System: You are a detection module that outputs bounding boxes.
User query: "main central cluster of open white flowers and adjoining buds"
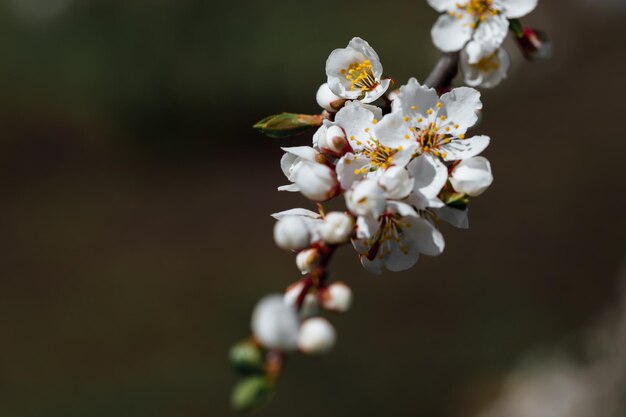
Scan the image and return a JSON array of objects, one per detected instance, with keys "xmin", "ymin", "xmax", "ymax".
[{"xmin": 274, "ymin": 38, "xmax": 493, "ymax": 273}]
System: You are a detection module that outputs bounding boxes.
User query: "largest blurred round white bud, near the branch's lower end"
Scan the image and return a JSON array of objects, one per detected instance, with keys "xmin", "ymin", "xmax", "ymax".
[{"xmin": 252, "ymin": 295, "xmax": 299, "ymax": 352}]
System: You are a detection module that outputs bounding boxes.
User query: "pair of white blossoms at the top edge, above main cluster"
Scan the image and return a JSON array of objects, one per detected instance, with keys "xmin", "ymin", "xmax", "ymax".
[{"xmin": 428, "ymin": 0, "xmax": 538, "ymax": 88}]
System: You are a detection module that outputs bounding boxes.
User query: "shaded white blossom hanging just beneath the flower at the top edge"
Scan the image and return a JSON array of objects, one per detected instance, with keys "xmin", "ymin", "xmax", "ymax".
[{"xmin": 460, "ymin": 48, "xmax": 511, "ymax": 88}]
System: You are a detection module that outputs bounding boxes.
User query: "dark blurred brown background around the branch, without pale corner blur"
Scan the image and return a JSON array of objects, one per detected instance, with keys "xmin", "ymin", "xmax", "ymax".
[{"xmin": 0, "ymin": 0, "xmax": 626, "ymax": 417}]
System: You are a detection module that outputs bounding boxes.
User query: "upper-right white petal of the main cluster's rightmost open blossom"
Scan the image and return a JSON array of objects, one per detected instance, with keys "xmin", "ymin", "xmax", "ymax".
[{"xmin": 441, "ymin": 87, "xmax": 483, "ymax": 135}]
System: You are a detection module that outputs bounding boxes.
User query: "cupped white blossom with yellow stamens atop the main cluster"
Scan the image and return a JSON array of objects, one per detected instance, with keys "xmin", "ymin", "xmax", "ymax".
[{"xmin": 326, "ymin": 38, "xmax": 391, "ymax": 103}]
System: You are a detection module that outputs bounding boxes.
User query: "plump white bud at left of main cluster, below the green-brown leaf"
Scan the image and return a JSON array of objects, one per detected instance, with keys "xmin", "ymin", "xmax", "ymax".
[{"xmin": 293, "ymin": 161, "xmax": 339, "ymax": 201}]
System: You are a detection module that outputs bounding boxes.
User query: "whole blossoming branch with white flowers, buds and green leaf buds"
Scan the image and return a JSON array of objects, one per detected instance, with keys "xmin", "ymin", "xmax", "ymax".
[{"xmin": 230, "ymin": 0, "xmax": 549, "ymax": 410}]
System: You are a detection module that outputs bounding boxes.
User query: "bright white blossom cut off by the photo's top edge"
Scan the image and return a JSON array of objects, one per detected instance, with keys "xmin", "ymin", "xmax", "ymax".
[{"xmin": 428, "ymin": 0, "xmax": 537, "ymax": 64}]
